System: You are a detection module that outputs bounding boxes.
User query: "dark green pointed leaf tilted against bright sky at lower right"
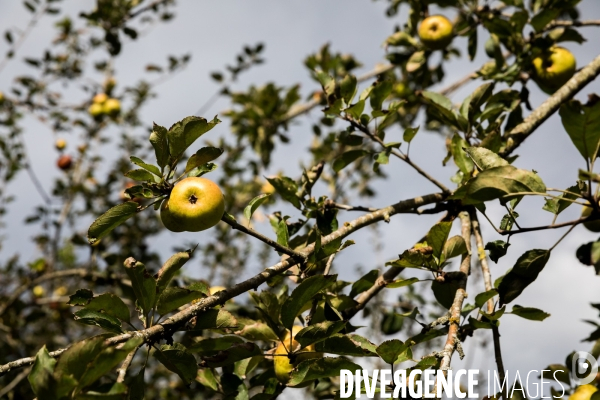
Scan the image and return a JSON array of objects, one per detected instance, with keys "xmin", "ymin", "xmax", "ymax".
[{"xmin": 498, "ymin": 249, "xmax": 550, "ymax": 305}]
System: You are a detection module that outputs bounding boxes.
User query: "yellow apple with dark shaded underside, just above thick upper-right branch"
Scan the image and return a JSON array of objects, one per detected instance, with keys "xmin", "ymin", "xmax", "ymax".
[{"xmin": 533, "ymin": 46, "xmax": 577, "ymax": 94}]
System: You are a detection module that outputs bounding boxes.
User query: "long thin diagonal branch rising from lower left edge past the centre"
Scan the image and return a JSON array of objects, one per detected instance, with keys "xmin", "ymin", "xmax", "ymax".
[{"xmin": 0, "ymin": 193, "xmax": 446, "ymax": 376}]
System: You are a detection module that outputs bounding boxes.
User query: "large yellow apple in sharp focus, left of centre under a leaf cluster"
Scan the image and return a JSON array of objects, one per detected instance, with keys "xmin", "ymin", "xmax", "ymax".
[{"xmin": 160, "ymin": 177, "xmax": 225, "ymax": 232}]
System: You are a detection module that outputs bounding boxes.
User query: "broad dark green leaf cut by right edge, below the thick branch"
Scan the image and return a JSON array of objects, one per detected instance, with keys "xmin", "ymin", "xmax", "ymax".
[{"xmin": 559, "ymin": 100, "xmax": 600, "ymax": 160}]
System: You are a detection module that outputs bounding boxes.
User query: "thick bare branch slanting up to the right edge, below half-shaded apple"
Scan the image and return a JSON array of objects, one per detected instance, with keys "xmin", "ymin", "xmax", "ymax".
[{"xmin": 499, "ymin": 52, "xmax": 600, "ymax": 157}]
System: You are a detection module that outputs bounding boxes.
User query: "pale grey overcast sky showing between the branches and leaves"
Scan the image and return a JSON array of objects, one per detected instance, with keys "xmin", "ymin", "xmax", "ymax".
[{"xmin": 0, "ymin": 0, "xmax": 600, "ymax": 394}]
